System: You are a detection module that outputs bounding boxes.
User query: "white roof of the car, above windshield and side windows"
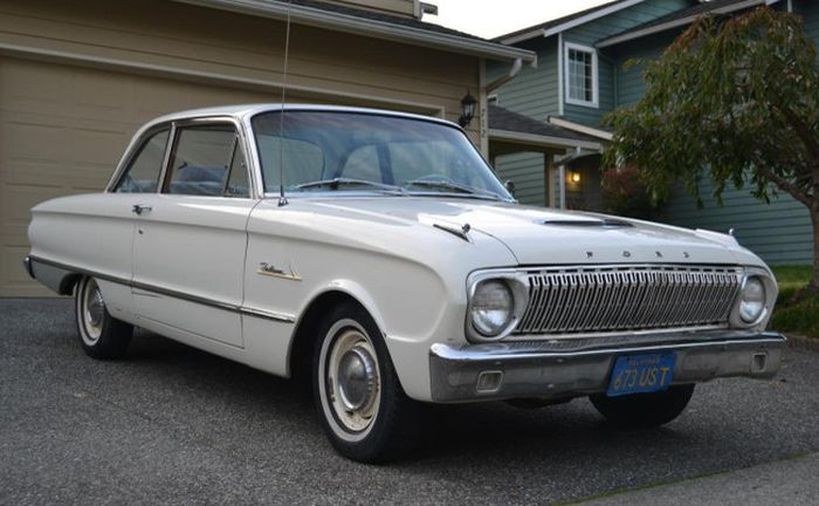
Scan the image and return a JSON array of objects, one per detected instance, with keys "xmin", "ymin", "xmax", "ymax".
[{"xmin": 143, "ymin": 103, "xmax": 460, "ymax": 130}]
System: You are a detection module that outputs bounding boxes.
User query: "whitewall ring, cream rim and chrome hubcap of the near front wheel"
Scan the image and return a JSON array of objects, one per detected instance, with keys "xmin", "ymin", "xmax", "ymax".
[{"xmin": 322, "ymin": 321, "xmax": 381, "ymax": 437}]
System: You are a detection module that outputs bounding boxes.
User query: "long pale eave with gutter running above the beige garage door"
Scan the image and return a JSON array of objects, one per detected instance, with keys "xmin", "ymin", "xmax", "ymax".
[{"xmin": 172, "ymin": 0, "xmax": 537, "ymax": 65}]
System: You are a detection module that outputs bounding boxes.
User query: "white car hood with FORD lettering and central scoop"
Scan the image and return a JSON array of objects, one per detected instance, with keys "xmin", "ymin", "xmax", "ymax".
[{"xmin": 304, "ymin": 197, "xmax": 761, "ymax": 265}]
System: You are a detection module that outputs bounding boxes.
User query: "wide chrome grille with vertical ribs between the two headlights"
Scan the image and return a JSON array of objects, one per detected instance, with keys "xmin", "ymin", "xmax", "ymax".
[{"xmin": 514, "ymin": 265, "xmax": 742, "ymax": 335}]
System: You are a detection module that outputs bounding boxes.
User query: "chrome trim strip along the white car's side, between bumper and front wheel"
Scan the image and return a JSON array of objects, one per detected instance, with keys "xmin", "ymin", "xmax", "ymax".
[{"xmin": 28, "ymin": 256, "xmax": 296, "ymax": 323}]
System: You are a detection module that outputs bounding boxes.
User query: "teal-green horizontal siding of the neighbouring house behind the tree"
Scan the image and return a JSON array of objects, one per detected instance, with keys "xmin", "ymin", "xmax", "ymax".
[{"xmin": 488, "ymin": 0, "xmax": 819, "ymax": 265}]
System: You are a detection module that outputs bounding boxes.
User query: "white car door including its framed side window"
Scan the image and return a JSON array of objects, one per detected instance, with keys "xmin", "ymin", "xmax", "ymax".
[{"xmin": 133, "ymin": 119, "xmax": 257, "ymax": 348}]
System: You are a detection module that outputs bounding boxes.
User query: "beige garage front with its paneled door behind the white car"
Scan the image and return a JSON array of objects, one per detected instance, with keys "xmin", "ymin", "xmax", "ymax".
[{"xmin": 0, "ymin": 0, "xmax": 485, "ymax": 297}]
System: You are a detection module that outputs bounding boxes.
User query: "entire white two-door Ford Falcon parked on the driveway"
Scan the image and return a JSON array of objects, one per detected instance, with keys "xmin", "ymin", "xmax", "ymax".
[{"xmin": 25, "ymin": 105, "xmax": 785, "ymax": 462}]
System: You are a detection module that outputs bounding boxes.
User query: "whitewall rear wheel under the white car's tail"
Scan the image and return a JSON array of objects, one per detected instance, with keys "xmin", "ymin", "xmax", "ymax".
[{"xmin": 74, "ymin": 277, "xmax": 134, "ymax": 359}]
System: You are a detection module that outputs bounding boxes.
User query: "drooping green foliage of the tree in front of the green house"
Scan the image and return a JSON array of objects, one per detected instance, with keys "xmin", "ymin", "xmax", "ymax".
[{"xmin": 605, "ymin": 7, "xmax": 819, "ymax": 288}]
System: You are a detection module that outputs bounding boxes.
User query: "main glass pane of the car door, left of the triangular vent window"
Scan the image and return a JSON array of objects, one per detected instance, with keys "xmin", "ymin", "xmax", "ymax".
[{"xmin": 167, "ymin": 125, "xmax": 236, "ymax": 196}]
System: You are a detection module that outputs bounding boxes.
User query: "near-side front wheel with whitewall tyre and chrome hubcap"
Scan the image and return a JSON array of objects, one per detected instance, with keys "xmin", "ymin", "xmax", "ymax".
[{"xmin": 313, "ymin": 303, "xmax": 419, "ymax": 463}]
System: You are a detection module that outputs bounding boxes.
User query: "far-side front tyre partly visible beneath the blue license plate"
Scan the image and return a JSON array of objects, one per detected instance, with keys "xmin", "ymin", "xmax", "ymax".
[{"xmin": 589, "ymin": 385, "xmax": 694, "ymax": 429}]
